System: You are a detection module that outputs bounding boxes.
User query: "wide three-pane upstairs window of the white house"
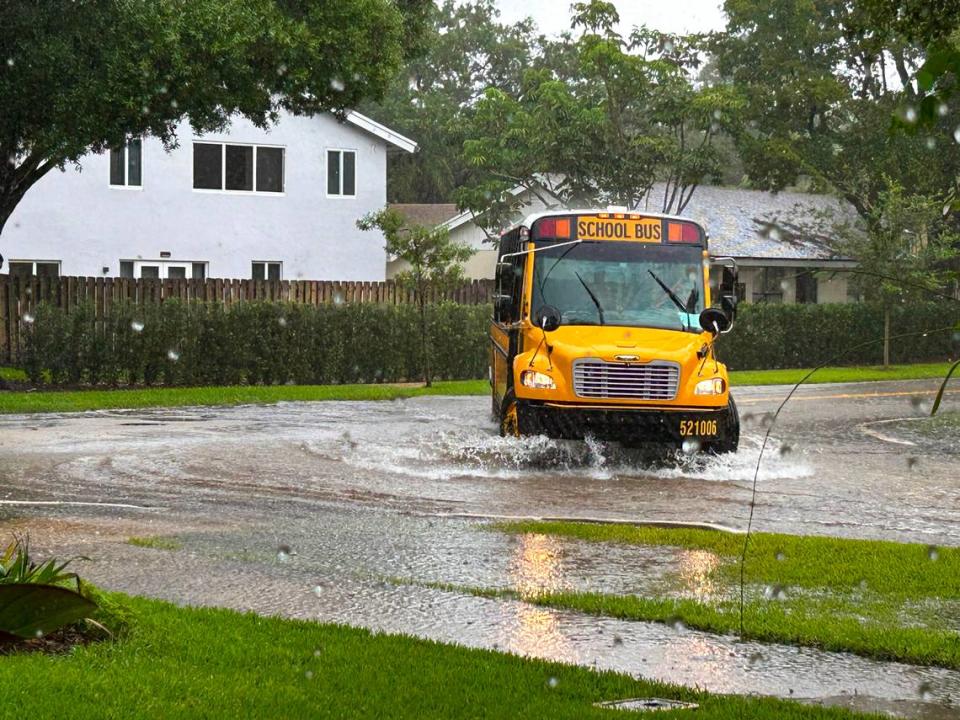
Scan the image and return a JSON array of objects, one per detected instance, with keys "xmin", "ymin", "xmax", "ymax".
[{"xmin": 193, "ymin": 142, "xmax": 284, "ymax": 193}]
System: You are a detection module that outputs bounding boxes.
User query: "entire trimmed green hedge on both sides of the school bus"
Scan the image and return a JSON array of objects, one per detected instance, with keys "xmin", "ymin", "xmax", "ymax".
[{"xmin": 15, "ymin": 301, "xmax": 960, "ymax": 385}]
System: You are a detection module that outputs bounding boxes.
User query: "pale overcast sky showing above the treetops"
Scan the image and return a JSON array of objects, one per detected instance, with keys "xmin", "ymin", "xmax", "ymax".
[{"xmin": 497, "ymin": 0, "xmax": 724, "ymax": 35}]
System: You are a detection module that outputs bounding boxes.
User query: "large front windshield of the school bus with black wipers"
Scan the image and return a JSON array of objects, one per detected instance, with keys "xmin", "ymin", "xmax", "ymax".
[{"xmin": 532, "ymin": 241, "xmax": 704, "ymax": 332}]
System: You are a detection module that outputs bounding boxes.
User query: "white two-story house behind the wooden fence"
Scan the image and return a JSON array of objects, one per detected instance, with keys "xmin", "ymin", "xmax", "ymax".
[{"xmin": 0, "ymin": 112, "xmax": 417, "ymax": 280}]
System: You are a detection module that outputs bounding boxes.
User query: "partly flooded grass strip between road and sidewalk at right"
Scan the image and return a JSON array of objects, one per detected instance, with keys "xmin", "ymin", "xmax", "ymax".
[{"xmin": 462, "ymin": 522, "xmax": 960, "ymax": 668}]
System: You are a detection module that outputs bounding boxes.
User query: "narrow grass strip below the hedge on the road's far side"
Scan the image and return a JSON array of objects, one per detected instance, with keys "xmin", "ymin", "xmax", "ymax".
[{"xmin": 0, "ymin": 363, "xmax": 949, "ymax": 413}]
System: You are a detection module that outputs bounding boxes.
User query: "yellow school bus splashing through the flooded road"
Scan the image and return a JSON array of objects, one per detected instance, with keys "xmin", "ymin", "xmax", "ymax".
[{"xmin": 490, "ymin": 210, "xmax": 740, "ymax": 453}]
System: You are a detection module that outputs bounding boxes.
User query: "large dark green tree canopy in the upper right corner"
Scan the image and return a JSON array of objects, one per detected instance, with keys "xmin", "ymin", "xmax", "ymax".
[{"xmin": 715, "ymin": 0, "xmax": 960, "ymax": 223}]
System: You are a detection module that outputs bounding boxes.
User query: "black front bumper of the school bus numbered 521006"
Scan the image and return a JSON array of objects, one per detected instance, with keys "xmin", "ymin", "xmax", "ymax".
[{"xmin": 517, "ymin": 401, "xmax": 739, "ymax": 445}]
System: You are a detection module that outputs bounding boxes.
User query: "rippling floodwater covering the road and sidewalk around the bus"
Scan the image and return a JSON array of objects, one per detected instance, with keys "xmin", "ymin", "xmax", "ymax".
[{"xmin": 0, "ymin": 381, "xmax": 960, "ymax": 718}]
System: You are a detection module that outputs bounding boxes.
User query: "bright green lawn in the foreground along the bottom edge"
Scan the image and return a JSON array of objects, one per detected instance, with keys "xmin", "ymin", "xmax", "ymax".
[{"xmin": 0, "ymin": 596, "xmax": 872, "ymax": 720}]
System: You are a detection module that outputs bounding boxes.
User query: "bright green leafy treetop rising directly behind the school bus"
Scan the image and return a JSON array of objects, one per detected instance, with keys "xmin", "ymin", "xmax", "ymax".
[{"xmin": 457, "ymin": 0, "xmax": 740, "ymax": 239}]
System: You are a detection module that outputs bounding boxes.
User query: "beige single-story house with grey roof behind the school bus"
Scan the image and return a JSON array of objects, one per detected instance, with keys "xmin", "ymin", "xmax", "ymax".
[{"xmin": 387, "ymin": 185, "xmax": 856, "ymax": 303}]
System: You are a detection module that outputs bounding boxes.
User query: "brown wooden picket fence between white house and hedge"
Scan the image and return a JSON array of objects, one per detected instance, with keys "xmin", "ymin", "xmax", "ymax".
[{"xmin": 0, "ymin": 275, "xmax": 494, "ymax": 363}]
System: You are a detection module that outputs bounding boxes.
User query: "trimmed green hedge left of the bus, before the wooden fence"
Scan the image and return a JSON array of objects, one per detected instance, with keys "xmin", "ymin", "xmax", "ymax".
[{"xmin": 23, "ymin": 301, "xmax": 491, "ymax": 385}]
